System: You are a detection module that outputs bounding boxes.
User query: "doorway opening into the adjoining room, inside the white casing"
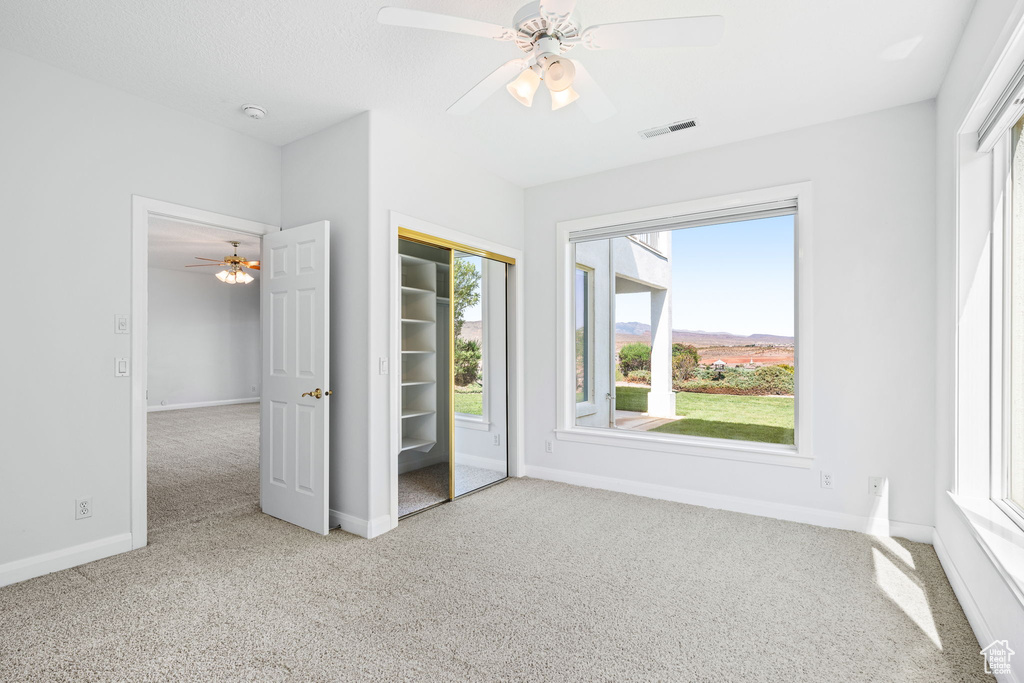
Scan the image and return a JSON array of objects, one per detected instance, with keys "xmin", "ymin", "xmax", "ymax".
[{"xmin": 146, "ymin": 216, "xmax": 262, "ymax": 531}]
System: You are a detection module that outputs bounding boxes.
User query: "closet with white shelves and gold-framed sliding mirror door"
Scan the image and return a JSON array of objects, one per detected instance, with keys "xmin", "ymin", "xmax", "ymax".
[{"xmin": 397, "ymin": 230, "xmax": 511, "ymax": 517}]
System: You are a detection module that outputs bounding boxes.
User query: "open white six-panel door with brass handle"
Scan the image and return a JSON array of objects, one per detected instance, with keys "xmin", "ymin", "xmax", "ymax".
[{"xmin": 259, "ymin": 220, "xmax": 331, "ymax": 533}]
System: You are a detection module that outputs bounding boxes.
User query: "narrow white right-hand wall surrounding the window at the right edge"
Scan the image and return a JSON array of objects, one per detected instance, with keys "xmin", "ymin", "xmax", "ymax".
[{"xmin": 935, "ymin": 0, "xmax": 1024, "ymax": 667}]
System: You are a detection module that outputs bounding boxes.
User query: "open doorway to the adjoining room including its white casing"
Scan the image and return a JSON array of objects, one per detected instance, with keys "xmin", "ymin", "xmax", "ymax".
[{"xmin": 130, "ymin": 197, "xmax": 281, "ymax": 548}]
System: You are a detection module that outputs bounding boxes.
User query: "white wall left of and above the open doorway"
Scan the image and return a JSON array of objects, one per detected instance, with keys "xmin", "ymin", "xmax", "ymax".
[{"xmin": 0, "ymin": 50, "xmax": 281, "ymax": 584}]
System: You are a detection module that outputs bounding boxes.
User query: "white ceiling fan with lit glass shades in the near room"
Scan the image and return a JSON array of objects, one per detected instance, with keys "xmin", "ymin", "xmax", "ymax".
[{"xmin": 377, "ymin": 0, "xmax": 725, "ymax": 122}]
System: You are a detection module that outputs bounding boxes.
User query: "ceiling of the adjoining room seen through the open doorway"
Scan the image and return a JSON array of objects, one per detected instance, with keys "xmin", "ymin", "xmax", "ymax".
[{"xmin": 150, "ymin": 217, "xmax": 262, "ymax": 278}]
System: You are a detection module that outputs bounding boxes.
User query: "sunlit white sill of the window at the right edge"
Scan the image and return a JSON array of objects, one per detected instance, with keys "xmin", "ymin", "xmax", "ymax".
[{"xmin": 947, "ymin": 492, "xmax": 1024, "ymax": 606}]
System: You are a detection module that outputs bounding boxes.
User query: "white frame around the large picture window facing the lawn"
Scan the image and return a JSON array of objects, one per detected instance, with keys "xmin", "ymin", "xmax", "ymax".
[{"xmin": 555, "ymin": 182, "xmax": 814, "ymax": 468}]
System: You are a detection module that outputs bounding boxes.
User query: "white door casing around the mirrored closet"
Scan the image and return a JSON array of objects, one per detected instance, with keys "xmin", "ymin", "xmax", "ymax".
[{"xmin": 388, "ymin": 211, "xmax": 526, "ymax": 528}]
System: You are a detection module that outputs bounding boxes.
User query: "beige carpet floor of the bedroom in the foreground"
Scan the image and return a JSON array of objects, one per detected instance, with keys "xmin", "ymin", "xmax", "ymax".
[{"xmin": 0, "ymin": 405, "xmax": 985, "ymax": 683}]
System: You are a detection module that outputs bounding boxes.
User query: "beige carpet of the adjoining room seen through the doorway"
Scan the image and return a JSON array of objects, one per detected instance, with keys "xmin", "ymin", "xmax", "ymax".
[{"xmin": 146, "ymin": 403, "xmax": 259, "ymax": 532}]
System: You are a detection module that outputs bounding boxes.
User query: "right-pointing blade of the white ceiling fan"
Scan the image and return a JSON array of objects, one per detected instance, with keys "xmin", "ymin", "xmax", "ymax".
[{"xmin": 581, "ymin": 15, "xmax": 725, "ymax": 50}]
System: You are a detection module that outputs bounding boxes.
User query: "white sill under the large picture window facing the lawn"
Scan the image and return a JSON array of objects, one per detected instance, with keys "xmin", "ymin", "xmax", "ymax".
[{"xmin": 555, "ymin": 427, "xmax": 814, "ymax": 469}]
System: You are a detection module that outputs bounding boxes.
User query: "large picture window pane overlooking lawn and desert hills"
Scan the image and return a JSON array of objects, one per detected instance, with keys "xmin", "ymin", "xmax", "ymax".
[{"xmin": 570, "ymin": 203, "xmax": 799, "ymax": 445}]
